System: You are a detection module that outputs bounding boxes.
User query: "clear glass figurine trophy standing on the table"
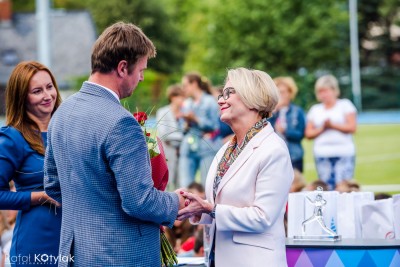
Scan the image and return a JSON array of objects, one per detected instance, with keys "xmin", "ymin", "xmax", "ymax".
[{"xmin": 293, "ymin": 186, "xmax": 341, "ymax": 241}]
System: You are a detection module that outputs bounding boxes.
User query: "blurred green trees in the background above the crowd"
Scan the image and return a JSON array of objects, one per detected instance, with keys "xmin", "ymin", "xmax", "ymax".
[{"xmin": 13, "ymin": 0, "xmax": 400, "ymax": 109}]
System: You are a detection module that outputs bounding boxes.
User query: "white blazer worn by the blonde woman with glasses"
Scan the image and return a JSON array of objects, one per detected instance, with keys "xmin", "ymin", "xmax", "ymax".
[{"xmin": 192, "ymin": 123, "xmax": 293, "ymax": 267}]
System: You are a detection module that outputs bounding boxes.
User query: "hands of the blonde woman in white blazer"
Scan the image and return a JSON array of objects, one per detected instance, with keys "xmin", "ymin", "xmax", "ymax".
[{"xmin": 177, "ymin": 191, "xmax": 214, "ymax": 220}]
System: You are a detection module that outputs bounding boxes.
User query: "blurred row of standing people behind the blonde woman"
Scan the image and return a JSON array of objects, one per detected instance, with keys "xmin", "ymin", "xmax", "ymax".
[{"xmin": 156, "ymin": 72, "xmax": 357, "ymax": 191}]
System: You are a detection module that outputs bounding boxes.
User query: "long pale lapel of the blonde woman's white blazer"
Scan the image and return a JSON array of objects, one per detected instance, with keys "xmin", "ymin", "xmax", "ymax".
[{"xmin": 214, "ymin": 123, "xmax": 274, "ymax": 198}]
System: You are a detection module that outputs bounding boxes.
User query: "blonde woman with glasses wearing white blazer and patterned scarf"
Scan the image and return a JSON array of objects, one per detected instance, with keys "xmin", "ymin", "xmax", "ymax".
[{"xmin": 178, "ymin": 68, "xmax": 293, "ymax": 267}]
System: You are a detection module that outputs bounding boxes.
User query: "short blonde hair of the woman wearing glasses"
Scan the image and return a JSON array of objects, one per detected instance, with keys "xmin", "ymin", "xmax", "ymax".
[{"xmin": 226, "ymin": 68, "xmax": 279, "ymax": 118}]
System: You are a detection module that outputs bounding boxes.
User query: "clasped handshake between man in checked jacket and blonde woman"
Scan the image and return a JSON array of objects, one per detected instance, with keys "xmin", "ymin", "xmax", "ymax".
[{"xmin": 175, "ymin": 191, "xmax": 214, "ymax": 221}]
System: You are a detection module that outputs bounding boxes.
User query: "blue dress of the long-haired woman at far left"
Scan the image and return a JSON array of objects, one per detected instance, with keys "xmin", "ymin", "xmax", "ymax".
[{"xmin": 0, "ymin": 127, "xmax": 61, "ymax": 266}]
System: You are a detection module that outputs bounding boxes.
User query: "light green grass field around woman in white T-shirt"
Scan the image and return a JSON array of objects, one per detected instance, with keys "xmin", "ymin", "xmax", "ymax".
[{"xmin": 303, "ymin": 124, "xmax": 400, "ymax": 192}]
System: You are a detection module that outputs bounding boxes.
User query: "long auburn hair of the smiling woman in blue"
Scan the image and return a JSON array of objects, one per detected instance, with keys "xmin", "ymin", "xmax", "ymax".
[{"xmin": 6, "ymin": 61, "xmax": 61, "ymax": 155}]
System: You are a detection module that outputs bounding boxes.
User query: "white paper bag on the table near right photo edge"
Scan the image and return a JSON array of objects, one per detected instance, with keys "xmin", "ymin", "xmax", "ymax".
[{"xmin": 361, "ymin": 198, "xmax": 395, "ymax": 239}]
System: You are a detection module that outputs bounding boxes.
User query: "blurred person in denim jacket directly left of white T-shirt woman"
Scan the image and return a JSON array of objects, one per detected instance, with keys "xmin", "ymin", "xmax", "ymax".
[{"xmin": 269, "ymin": 77, "xmax": 306, "ymax": 172}]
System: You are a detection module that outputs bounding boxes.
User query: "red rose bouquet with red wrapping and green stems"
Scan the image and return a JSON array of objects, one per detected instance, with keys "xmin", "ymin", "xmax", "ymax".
[{"xmin": 133, "ymin": 112, "xmax": 178, "ymax": 267}]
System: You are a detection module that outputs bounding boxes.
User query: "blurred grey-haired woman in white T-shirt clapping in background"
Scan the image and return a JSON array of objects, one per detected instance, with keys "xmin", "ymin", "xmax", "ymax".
[{"xmin": 305, "ymin": 75, "xmax": 357, "ymax": 190}]
